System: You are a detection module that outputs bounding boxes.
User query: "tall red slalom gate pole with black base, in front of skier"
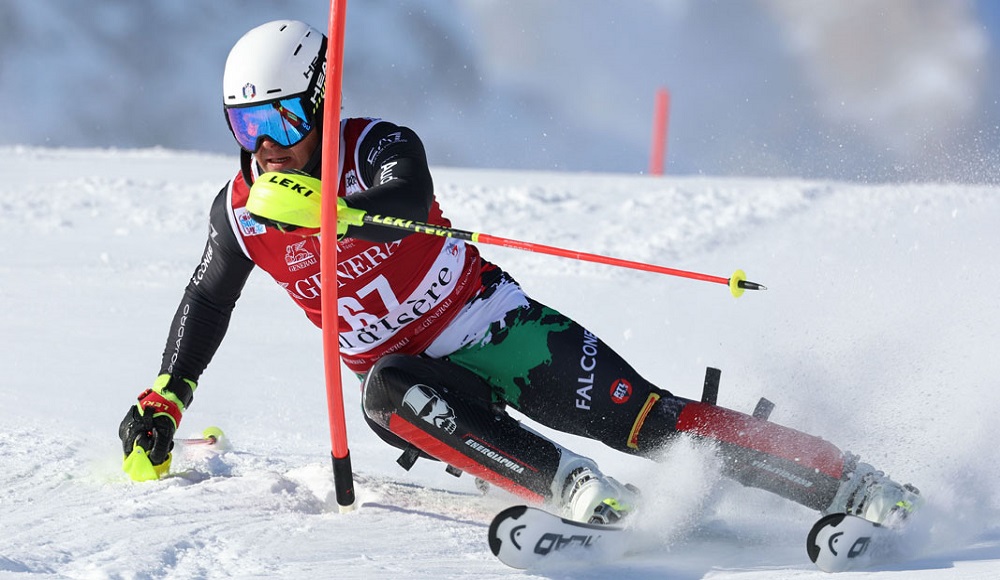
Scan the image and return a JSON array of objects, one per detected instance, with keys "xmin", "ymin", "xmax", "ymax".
[{"xmin": 320, "ymin": 0, "xmax": 355, "ymax": 512}]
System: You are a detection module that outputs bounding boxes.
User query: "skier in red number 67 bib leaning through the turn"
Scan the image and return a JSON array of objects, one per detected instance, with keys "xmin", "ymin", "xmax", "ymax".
[{"xmin": 119, "ymin": 20, "xmax": 919, "ymax": 523}]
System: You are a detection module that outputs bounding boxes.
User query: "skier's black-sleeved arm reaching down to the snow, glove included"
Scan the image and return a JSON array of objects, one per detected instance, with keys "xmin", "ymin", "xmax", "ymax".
[{"xmin": 118, "ymin": 187, "xmax": 254, "ymax": 480}]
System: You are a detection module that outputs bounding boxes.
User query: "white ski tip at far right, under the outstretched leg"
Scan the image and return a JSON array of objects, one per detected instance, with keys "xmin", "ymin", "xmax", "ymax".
[{"xmin": 806, "ymin": 514, "xmax": 899, "ymax": 572}]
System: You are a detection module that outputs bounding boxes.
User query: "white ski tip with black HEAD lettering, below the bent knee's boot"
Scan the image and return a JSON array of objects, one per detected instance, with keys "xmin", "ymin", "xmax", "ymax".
[{"xmin": 488, "ymin": 505, "xmax": 629, "ymax": 570}]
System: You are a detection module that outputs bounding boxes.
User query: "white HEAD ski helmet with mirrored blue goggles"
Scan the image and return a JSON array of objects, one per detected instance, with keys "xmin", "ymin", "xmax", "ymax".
[{"xmin": 222, "ymin": 20, "xmax": 326, "ymax": 151}]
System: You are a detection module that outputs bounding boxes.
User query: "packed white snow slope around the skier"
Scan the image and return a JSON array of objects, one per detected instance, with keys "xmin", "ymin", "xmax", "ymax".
[{"xmin": 0, "ymin": 147, "xmax": 1000, "ymax": 580}]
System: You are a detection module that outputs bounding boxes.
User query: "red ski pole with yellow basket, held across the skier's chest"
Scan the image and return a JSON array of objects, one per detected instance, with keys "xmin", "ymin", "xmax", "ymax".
[{"xmin": 358, "ymin": 209, "xmax": 767, "ymax": 298}]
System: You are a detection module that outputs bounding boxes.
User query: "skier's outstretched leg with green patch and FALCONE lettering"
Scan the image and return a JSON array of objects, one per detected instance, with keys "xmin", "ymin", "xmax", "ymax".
[{"xmin": 446, "ymin": 299, "xmax": 920, "ymax": 511}]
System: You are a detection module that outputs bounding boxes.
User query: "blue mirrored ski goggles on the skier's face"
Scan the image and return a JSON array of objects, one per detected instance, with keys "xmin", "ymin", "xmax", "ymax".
[{"xmin": 226, "ymin": 96, "xmax": 313, "ymax": 153}]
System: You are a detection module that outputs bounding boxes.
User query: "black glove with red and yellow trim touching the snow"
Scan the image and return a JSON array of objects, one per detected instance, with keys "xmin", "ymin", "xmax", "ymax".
[{"xmin": 118, "ymin": 374, "xmax": 197, "ymax": 481}]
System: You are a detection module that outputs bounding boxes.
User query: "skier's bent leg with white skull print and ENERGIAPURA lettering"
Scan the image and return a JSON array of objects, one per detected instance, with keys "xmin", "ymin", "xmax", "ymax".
[{"xmin": 362, "ymin": 355, "xmax": 632, "ymax": 521}]
